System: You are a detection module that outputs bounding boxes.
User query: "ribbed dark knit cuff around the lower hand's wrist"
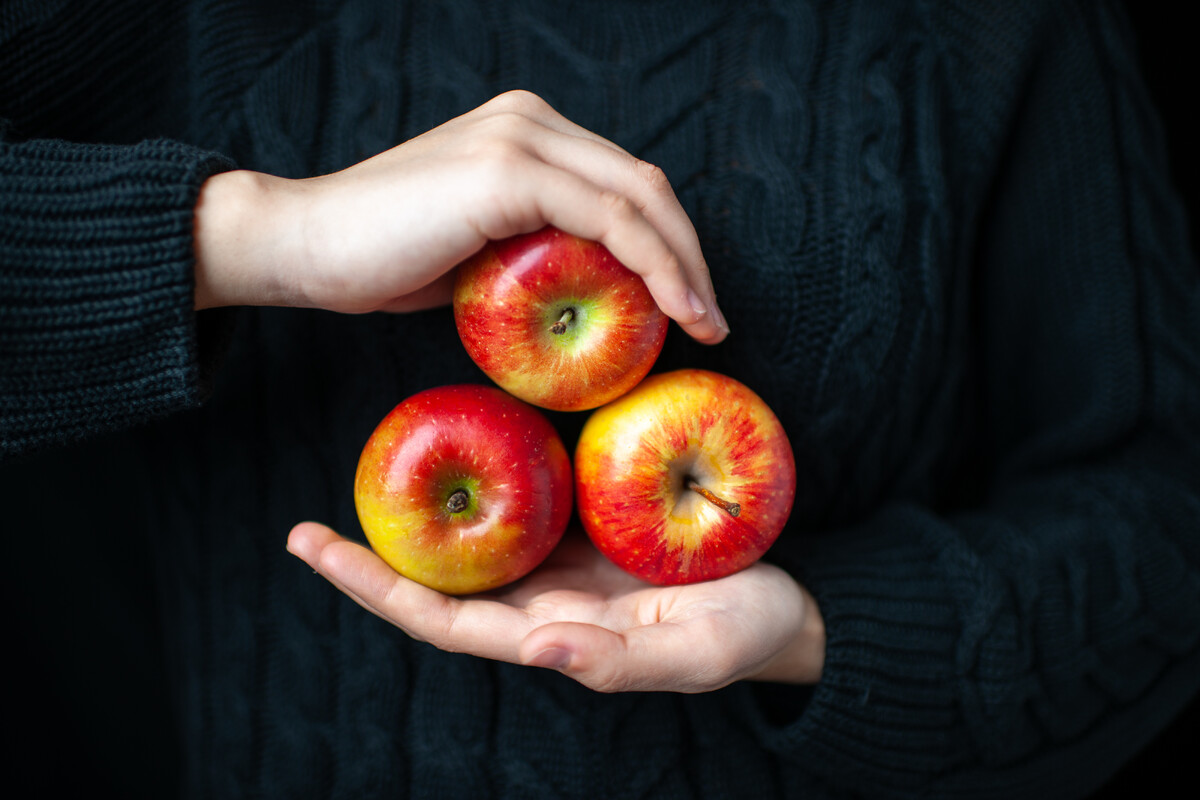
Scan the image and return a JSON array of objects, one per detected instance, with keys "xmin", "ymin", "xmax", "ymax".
[{"xmin": 750, "ymin": 507, "xmax": 967, "ymax": 796}]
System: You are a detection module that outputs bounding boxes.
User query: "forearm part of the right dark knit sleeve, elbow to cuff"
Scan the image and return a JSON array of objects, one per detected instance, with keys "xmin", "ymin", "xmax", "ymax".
[{"xmin": 749, "ymin": 479, "xmax": 1200, "ymax": 798}]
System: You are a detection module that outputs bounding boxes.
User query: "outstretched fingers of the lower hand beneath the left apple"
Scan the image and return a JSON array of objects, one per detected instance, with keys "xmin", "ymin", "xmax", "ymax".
[{"xmin": 288, "ymin": 522, "xmax": 532, "ymax": 663}]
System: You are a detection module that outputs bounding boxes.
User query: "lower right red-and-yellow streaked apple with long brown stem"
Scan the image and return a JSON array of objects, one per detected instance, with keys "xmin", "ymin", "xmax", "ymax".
[{"xmin": 575, "ymin": 369, "xmax": 796, "ymax": 585}]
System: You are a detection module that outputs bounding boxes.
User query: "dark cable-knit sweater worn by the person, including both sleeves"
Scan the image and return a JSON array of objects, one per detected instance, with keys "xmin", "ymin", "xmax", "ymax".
[{"xmin": 0, "ymin": 0, "xmax": 1200, "ymax": 799}]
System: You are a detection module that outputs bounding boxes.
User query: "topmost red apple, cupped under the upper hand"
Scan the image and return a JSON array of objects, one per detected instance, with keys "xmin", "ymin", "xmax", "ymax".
[{"xmin": 454, "ymin": 227, "xmax": 667, "ymax": 411}]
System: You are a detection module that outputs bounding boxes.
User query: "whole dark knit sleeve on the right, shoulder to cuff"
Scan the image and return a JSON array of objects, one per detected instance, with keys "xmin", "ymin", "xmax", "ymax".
[{"xmin": 754, "ymin": 4, "xmax": 1200, "ymax": 798}]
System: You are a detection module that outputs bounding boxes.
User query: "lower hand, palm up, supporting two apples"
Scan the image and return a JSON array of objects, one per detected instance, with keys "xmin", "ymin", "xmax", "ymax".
[{"xmin": 288, "ymin": 522, "xmax": 824, "ymax": 692}]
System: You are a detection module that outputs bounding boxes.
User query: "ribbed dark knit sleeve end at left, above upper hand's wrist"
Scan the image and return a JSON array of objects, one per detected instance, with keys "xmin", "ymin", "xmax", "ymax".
[{"xmin": 0, "ymin": 127, "xmax": 230, "ymax": 457}]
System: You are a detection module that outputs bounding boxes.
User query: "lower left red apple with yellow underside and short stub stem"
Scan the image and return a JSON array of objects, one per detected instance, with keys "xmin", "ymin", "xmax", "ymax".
[{"xmin": 354, "ymin": 384, "xmax": 572, "ymax": 595}]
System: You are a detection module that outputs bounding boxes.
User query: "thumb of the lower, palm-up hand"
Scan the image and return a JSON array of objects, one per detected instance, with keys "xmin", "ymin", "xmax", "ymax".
[{"xmin": 520, "ymin": 622, "xmax": 740, "ymax": 693}]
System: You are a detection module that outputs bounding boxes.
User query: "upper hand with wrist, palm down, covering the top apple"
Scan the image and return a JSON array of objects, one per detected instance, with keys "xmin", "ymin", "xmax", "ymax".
[{"xmin": 196, "ymin": 91, "xmax": 728, "ymax": 343}]
